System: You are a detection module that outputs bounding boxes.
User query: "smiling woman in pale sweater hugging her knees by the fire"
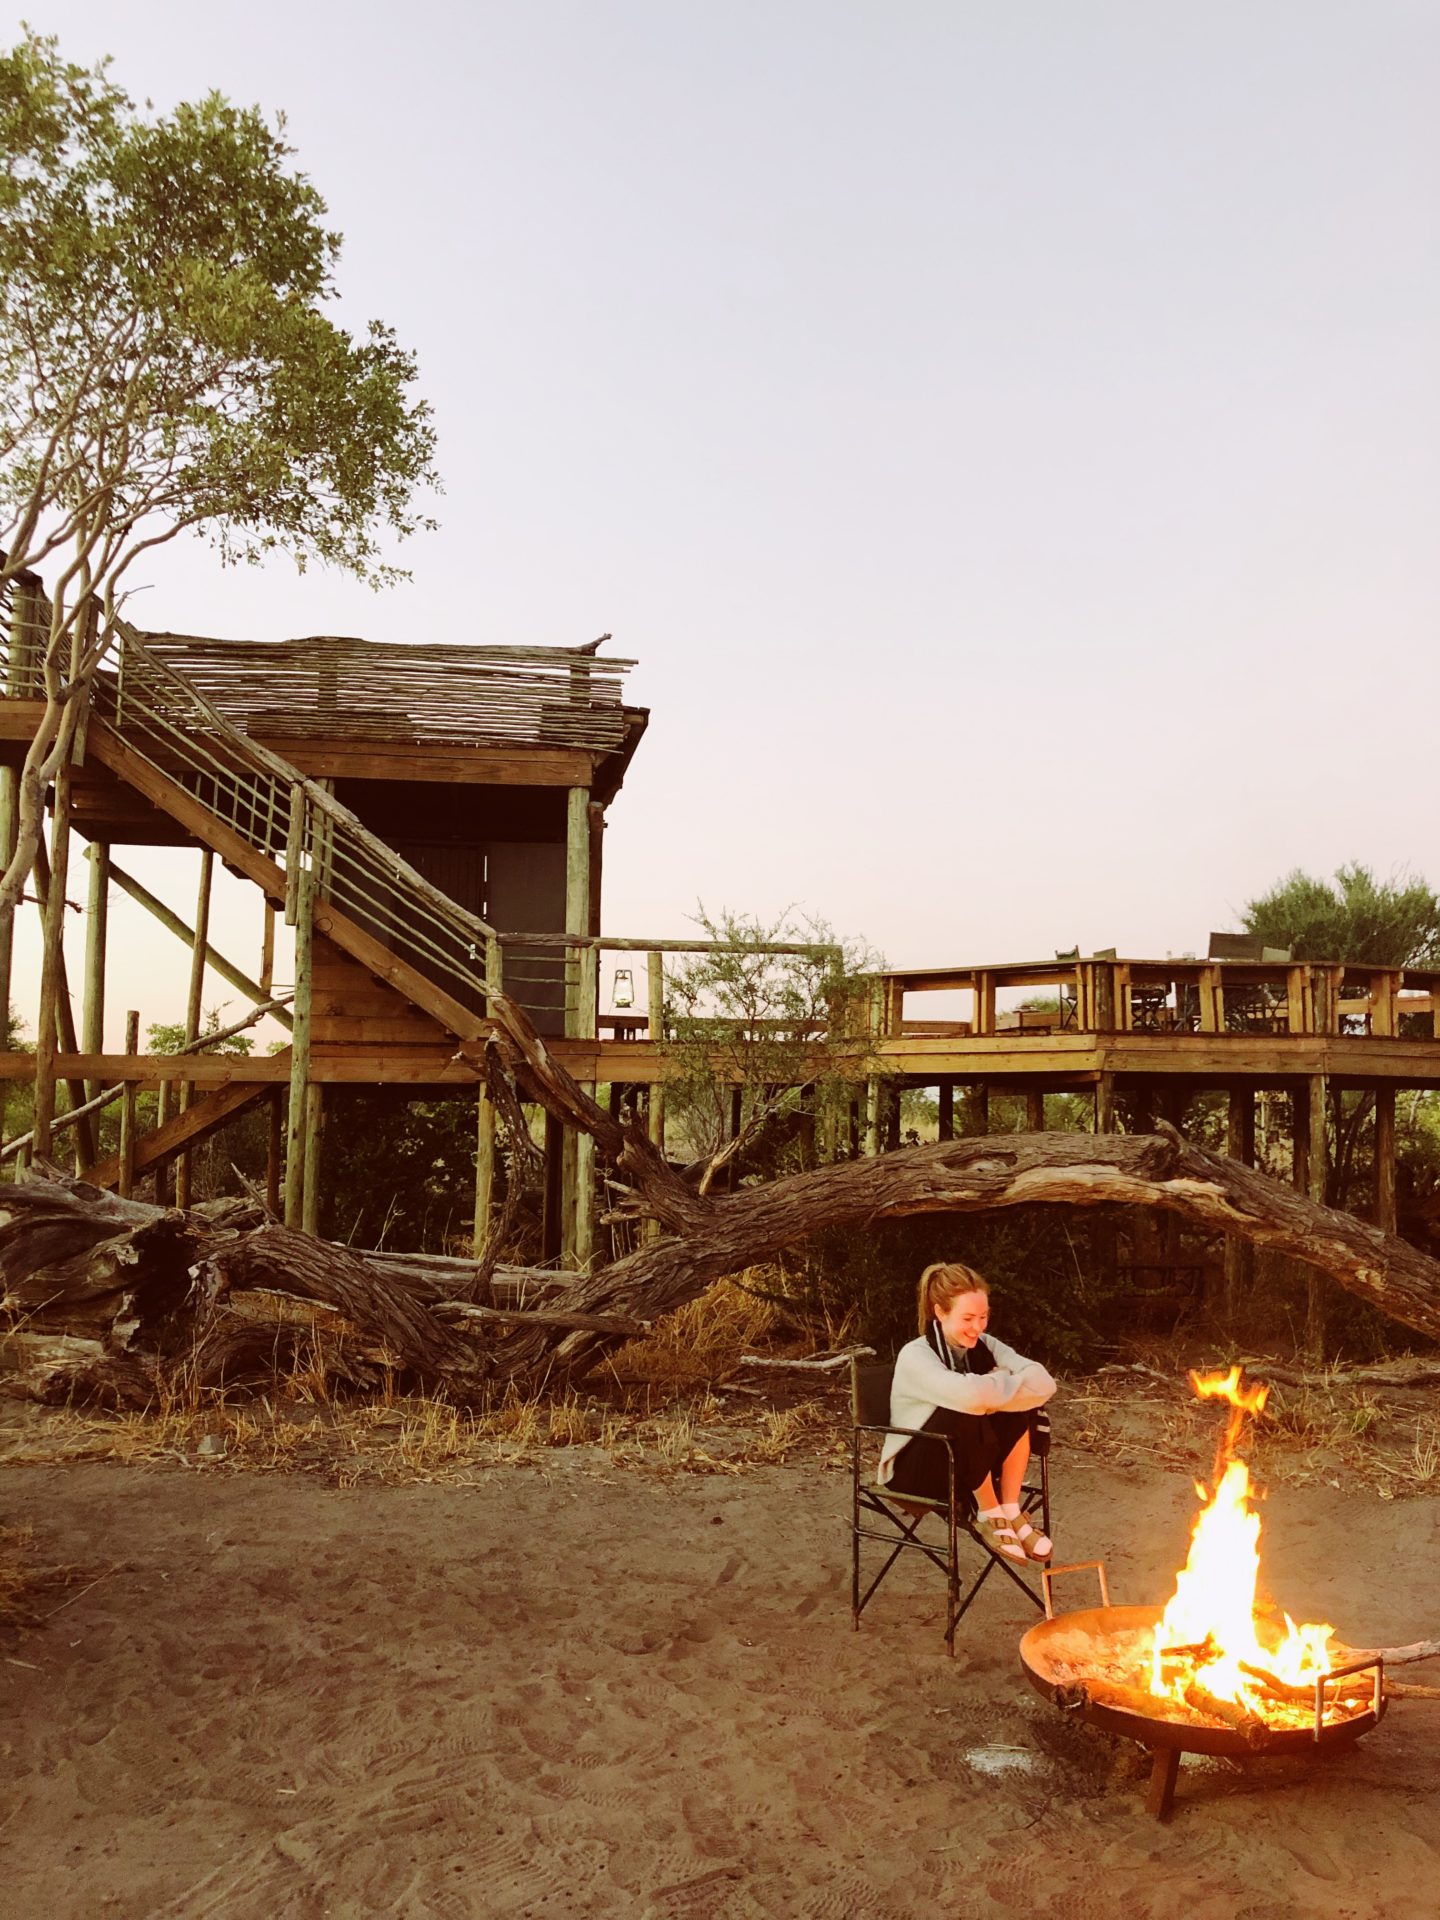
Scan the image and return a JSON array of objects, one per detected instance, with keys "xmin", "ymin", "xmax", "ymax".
[{"xmin": 879, "ymin": 1261, "xmax": 1054, "ymax": 1565}]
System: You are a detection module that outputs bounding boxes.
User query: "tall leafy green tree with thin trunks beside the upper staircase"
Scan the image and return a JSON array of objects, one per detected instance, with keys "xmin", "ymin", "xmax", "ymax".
[{"xmin": 0, "ymin": 33, "xmax": 436, "ymax": 910}]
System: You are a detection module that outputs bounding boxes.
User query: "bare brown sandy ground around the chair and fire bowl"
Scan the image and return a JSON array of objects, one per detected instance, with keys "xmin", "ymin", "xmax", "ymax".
[{"xmin": 0, "ymin": 1450, "xmax": 1440, "ymax": 1920}]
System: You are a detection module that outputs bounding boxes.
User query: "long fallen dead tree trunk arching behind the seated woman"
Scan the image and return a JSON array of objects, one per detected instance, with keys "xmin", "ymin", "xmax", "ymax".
[{"xmin": 0, "ymin": 1089, "xmax": 1440, "ymax": 1400}]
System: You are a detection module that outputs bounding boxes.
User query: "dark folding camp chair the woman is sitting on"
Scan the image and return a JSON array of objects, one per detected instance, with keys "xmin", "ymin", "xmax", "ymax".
[{"xmin": 851, "ymin": 1359, "xmax": 1050, "ymax": 1657}]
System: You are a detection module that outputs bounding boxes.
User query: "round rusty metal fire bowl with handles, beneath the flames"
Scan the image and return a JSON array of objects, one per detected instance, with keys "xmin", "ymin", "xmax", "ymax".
[{"xmin": 1020, "ymin": 1561, "xmax": 1384, "ymax": 1820}]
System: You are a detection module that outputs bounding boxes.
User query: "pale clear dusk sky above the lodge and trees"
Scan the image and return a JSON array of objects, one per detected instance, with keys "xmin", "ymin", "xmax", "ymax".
[{"xmin": 15, "ymin": 0, "xmax": 1440, "ymax": 1044}]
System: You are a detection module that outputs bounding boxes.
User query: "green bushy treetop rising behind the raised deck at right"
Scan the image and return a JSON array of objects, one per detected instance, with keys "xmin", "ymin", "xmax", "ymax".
[{"xmin": 1242, "ymin": 862, "xmax": 1440, "ymax": 966}]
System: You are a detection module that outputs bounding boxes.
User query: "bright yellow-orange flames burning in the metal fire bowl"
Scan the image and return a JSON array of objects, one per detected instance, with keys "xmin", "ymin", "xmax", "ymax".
[{"xmin": 1150, "ymin": 1367, "xmax": 1334, "ymax": 1722}]
